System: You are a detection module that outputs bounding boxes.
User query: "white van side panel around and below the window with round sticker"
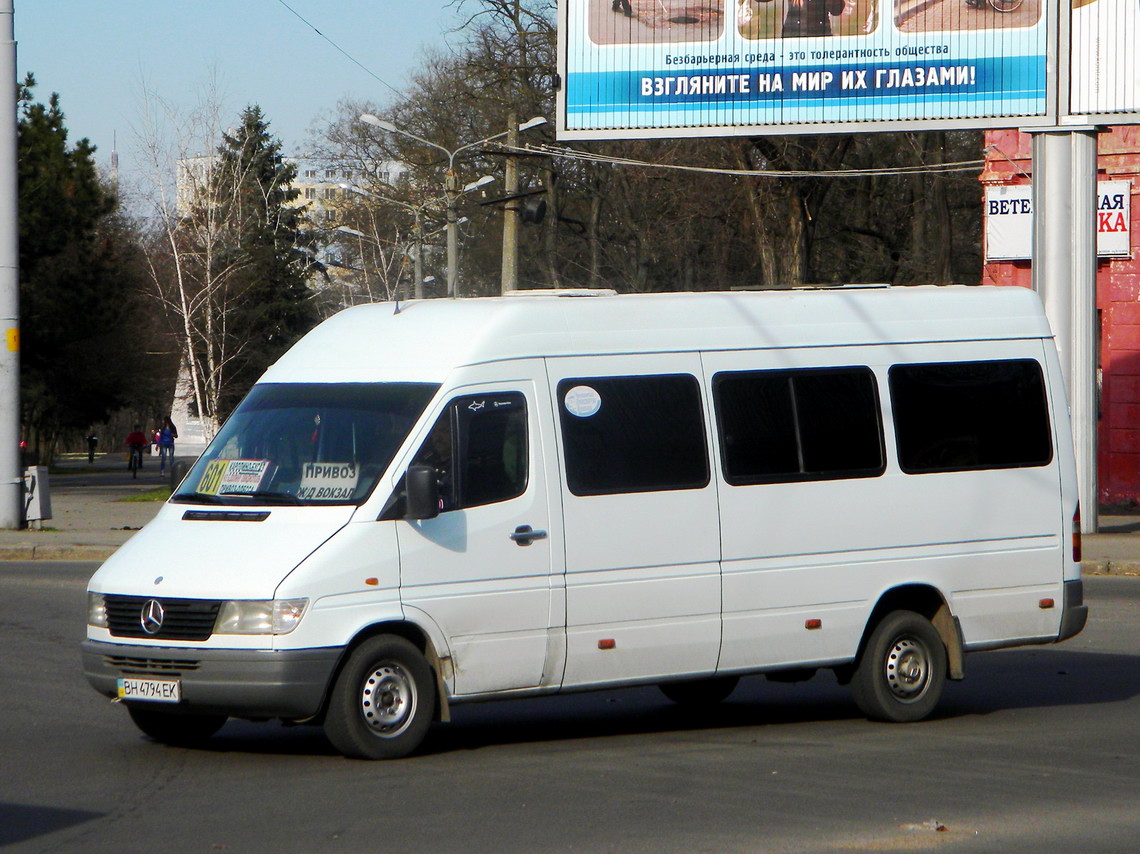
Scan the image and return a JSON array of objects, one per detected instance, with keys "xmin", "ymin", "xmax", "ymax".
[{"xmin": 547, "ymin": 353, "xmax": 720, "ymax": 686}]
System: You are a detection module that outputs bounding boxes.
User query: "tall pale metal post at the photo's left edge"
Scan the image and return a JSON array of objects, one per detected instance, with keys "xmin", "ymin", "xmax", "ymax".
[{"xmin": 0, "ymin": 0, "xmax": 24, "ymax": 528}]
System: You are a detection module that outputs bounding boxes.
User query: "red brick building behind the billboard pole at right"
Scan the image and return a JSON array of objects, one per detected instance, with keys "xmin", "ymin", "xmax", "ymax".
[{"xmin": 982, "ymin": 127, "xmax": 1140, "ymax": 506}]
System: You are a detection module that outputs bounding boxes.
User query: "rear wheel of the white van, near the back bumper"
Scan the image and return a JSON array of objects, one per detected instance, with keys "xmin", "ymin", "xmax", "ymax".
[{"xmin": 852, "ymin": 611, "xmax": 946, "ymax": 723}]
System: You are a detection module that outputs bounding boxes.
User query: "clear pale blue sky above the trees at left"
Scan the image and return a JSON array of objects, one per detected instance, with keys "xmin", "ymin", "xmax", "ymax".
[{"xmin": 15, "ymin": 0, "xmax": 472, "ymax": 180}]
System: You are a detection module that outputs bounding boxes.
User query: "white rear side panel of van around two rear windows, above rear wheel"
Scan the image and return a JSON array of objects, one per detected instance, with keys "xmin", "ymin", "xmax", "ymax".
[{"xmin": 705, "ymin": 340, "xmax": 1064, "ymax": 672}]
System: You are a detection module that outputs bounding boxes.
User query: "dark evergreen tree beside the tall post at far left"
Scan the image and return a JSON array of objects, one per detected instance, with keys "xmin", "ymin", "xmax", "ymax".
[{"xmin": 18, "ymin": 74, "xmax": 148, "ymax": 456}]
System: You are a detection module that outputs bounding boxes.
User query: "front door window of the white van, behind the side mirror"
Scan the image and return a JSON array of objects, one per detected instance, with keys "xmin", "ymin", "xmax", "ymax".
[{"xmin": 412, "ymin": 392, "xmax": 528, "ymax": 512}]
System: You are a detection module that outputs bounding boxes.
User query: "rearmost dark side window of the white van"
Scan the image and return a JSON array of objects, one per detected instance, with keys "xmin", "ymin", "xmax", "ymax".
[{"xmin": 889, "ymin": 359, "xmax": 1053, "ymax": 474}]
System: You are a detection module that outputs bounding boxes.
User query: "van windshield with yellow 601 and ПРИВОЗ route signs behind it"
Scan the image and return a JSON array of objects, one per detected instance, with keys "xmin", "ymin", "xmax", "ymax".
[{"xmin": 172, "ymin": 383, "xmax": 439, "ymax": 505}]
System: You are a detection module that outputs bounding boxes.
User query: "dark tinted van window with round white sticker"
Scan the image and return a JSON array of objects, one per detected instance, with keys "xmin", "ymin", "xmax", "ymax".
[{"xmin": 557, "ymin": 374, "xmax": 709, "ymax": 495}]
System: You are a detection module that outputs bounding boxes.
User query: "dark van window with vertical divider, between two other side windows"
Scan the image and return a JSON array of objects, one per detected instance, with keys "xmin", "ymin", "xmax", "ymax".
[{"xmin": 713, "ymin": 367, "xmax": 886, "ymax": 486}]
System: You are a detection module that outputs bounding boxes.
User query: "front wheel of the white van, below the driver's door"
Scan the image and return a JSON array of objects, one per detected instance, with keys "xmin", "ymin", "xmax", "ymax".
[{"xmin": 325, "ymin": 635, "xmax": 435, "ymax": 759}]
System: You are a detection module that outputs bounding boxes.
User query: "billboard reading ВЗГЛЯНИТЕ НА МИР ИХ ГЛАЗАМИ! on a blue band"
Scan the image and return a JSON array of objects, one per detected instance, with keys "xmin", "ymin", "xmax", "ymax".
[{"xmin": 559, "ymin": 0, "xmax": 1048, "ymax": 139}]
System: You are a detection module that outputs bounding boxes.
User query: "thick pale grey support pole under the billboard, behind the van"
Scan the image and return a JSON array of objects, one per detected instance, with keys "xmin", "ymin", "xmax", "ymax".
[{"xmin": 1027, "ymin": 127, "xmax": 1099, "ymax": 534}]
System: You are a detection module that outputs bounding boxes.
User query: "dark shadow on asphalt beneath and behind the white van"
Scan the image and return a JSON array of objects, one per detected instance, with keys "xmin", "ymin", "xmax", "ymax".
[{"xmin": 156, "ymin": 648, "xmax": 1140, "ymax": 756}]
